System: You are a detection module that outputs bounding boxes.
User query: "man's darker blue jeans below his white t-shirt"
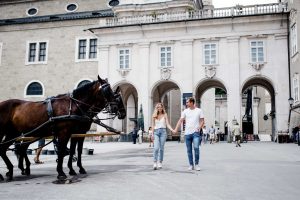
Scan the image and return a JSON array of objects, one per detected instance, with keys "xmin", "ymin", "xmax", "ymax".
[{"xmin": 185, "ymin": 132, "xmax": 202, "ymax": 166}]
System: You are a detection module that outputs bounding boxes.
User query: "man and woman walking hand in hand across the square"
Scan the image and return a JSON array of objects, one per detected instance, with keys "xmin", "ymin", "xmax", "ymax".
[{"xmin": 152, "ymin": 97, "xmax": 204, "ymax": 171}]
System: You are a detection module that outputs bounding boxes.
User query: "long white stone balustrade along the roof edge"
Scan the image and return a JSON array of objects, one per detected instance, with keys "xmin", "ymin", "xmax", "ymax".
[{"xmin": 105, "ymin": 3, "xmax": 287, "ymax": 26}]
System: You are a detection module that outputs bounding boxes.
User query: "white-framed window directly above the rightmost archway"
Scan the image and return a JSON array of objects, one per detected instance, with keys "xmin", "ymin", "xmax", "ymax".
[{"xmin": 250, "ymin": 41, "xmax": 265, "ymax": 63}]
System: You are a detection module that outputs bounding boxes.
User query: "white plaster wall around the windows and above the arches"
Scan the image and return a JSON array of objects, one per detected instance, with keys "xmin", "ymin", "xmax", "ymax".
[{"xmin": 95, "ymin": 13, "xmax": 288, "ymax": 136}]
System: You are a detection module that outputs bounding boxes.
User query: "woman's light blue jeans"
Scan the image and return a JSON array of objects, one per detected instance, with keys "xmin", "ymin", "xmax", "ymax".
[{"xmin": 153, "ymin": 128, "xmax": 167, "ymax": 162}]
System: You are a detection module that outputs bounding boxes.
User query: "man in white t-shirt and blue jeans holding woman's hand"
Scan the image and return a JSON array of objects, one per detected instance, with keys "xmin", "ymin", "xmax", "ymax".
[{"xmin": 174, "ymin": 97, "xmax": 204, "ymax": 171}]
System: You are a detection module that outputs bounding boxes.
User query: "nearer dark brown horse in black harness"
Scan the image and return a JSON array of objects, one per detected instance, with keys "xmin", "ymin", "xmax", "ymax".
[{"xmin": 0, "ymin": 76, "xmax": 126, "ymax": 180}]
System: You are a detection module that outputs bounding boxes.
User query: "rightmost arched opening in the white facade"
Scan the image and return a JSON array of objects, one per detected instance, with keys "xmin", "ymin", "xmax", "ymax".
[{"xmin": 241, "ymin": 77, "xmax": 276, "ymax": 141}]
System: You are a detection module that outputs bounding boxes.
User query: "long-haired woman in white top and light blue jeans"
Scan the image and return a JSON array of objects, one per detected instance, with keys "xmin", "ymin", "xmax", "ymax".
[{"xmin": 151, "ymin": 103, "xmax": 174, "ymax": 170}]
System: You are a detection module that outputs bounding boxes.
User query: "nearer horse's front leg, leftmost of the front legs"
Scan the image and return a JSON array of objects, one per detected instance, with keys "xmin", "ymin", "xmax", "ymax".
[{"xmin": 56, "ymin": 138, "xmax": 68, "ymax": 180}]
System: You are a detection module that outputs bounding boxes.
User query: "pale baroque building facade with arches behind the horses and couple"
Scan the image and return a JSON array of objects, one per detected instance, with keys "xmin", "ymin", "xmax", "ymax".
[{"xmin": 0, "ymin": 0, "xmax": 296, "ymax": 140}]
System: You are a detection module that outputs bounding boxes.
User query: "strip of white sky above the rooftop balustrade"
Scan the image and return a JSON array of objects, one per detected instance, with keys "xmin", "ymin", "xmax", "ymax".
[{"xmin": 212, "ymin": 0, "xmax": 278, "ymax": 8}]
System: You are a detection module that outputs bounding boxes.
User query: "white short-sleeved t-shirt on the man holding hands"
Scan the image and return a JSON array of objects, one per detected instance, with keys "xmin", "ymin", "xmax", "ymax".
[{"xmin": 181, "ymin": 107, "xmax": 204, "ymax": 135}]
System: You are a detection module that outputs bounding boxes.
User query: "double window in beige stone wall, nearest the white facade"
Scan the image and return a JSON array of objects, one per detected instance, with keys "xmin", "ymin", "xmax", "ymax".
[{"xmin": 76, "ymin": 38, "xmax": 97, "ymax": 61}]
